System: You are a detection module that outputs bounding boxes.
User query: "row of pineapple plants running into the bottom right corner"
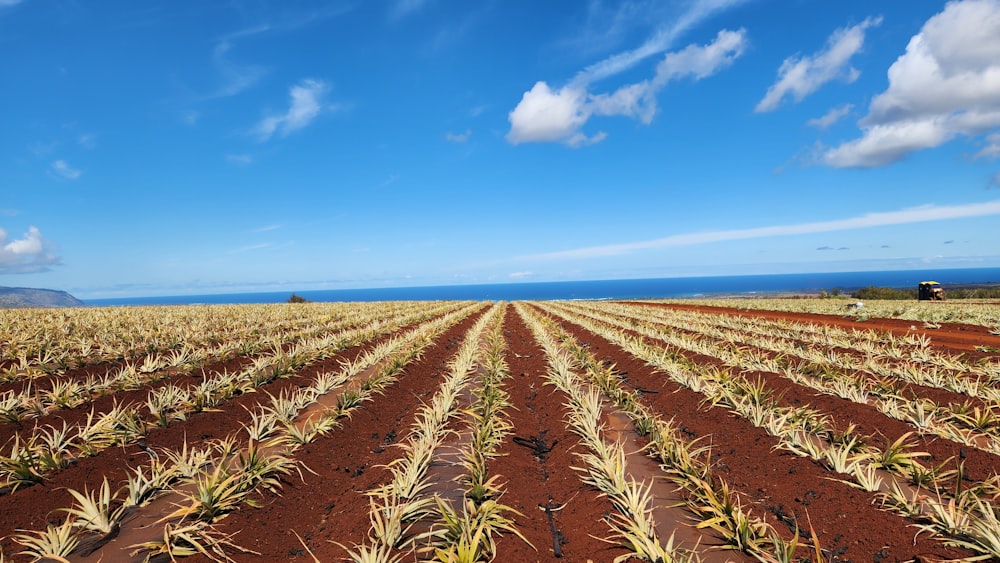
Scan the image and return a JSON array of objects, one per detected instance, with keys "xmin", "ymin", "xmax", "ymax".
[{"xmin": 545, "ymin": 305, "xmax": 1000, "ymax": 557}]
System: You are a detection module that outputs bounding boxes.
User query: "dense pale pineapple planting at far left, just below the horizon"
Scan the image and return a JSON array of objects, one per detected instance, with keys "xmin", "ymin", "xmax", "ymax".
[{"xmin": 0, "ymin": 303, "xmax": 458, "ymax": 380}]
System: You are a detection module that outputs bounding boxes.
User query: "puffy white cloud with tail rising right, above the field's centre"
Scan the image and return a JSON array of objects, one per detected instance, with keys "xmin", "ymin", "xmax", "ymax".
[{"xmin": 507, "ymin": 30, "xmax": 746, "ymax": 146}]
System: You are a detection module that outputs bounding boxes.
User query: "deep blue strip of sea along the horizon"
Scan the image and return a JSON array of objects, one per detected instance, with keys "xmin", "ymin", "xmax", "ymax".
[{"xmin": 84, "ymin": 268, "xmax": 1000, "ymax": 307}]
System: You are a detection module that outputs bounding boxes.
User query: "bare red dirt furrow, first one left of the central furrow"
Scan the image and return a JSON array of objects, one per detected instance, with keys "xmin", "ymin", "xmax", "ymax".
[{"xmin": 193, "ymin": 311, "xmax": 483, "ymax": 562}]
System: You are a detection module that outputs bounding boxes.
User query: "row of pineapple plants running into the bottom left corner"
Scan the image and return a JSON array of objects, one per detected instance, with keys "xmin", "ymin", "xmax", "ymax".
[{"xmin": 5, "ymin": 305, "xmax": 484, "ymax": 559}]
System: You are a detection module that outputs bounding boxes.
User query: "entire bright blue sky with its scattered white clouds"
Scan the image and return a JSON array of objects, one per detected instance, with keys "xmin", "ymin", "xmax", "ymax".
[{"xmin": 0, "ymin": 0, "xmax": 1000, "ymax": 298}]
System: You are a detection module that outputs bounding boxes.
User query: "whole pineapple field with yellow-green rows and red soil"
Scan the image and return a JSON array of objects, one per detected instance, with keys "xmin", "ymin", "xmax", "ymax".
[{"xmin": 0, "ymin": 299, "xmax": 1000, "ymax": 562}]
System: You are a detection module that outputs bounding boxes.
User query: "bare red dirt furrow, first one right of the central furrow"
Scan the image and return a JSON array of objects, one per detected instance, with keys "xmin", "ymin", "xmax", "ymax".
[{"xmin": 540, "ymin": 306, "xmax": 970, "ymax": 561}]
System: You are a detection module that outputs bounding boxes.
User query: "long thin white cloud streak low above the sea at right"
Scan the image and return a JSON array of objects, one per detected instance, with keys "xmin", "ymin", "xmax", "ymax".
[{"xmin": 522, "ymin": 200, "xmax": 1000, "ymax": 260}]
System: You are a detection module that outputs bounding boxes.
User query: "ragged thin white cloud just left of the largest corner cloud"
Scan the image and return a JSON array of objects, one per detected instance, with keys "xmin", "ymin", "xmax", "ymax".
[{"xmin": 754, "ymin": 18, "xmax": 882, "ymax": 113}]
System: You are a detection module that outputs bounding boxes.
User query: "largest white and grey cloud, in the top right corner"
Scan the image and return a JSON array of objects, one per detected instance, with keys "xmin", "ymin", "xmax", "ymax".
[{"xmin": 821, "ymin": 0, "xmax": 1000, "ymax": 168}]
